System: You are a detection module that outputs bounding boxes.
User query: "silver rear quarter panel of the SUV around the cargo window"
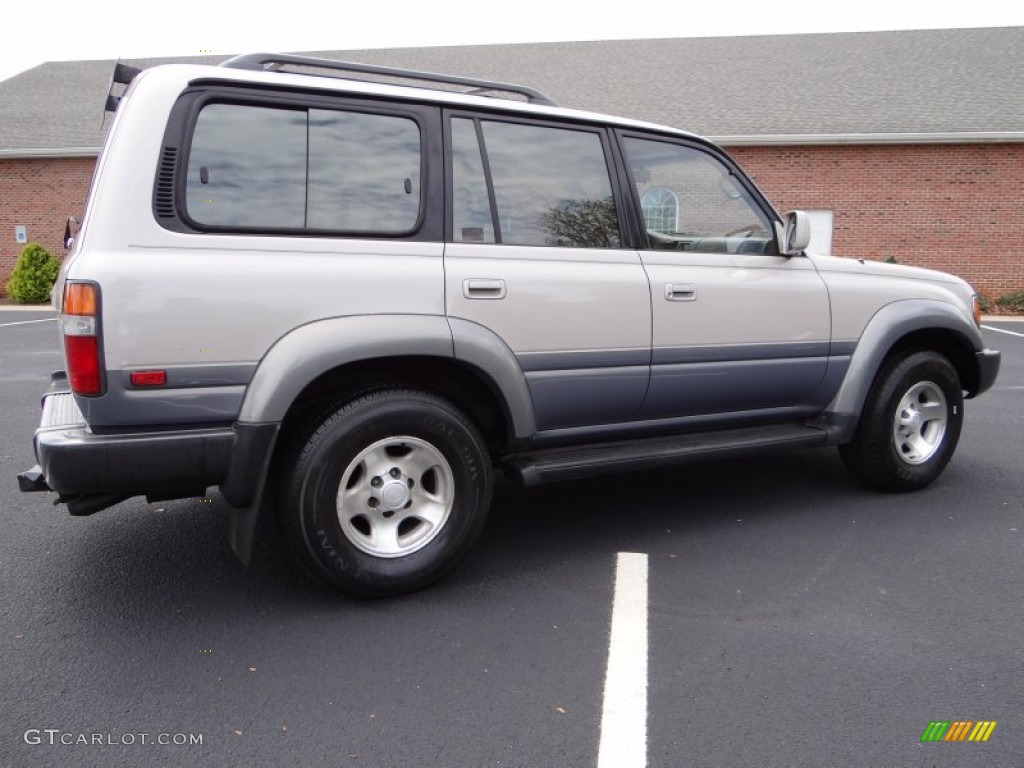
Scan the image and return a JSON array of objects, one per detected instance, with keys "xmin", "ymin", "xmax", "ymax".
[{"xmin": 65, "ymin": 67, "xmax": 444, "ymax": 424}]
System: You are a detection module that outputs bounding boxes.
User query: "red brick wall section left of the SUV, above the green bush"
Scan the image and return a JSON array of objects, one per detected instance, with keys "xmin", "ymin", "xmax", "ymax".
[{"xmin": 0, "ymin": 158, "xmax": 95, "ymax": 290}]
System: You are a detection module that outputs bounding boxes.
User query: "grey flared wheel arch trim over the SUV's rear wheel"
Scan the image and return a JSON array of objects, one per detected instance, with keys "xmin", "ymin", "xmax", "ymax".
[{"xmin": 221, "ymin": 314, "xmax": 536, "ymax": 518}]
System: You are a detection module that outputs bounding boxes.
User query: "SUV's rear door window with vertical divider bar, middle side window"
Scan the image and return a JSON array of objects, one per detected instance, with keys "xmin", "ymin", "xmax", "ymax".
[{"xmin": 453, "ymin": 119, "xmax": 622, "ymax": 248}]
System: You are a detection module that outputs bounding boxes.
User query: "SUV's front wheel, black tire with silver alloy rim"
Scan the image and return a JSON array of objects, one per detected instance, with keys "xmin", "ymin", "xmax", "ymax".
[{"xmin": 840, "ymin": 351, "xmax": 964, "ymax": 492}]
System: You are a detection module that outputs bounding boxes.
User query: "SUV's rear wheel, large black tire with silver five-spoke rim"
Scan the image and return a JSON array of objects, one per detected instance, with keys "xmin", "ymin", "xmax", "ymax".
[{"xmin": 279, "ymin": 389, "xmax": 490, "ymax": 597}]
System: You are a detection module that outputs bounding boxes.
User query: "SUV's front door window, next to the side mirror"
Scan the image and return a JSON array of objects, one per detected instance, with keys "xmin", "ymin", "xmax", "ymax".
[{"xmin": 623, "ymin": 137, "xmax": 775, "ymax": 253}]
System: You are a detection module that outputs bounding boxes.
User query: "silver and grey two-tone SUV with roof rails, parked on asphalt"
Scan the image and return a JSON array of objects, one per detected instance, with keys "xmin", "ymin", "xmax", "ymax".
[{"xmin": 19, "ymin": 55, "xmax": 999, "ymax": 596}]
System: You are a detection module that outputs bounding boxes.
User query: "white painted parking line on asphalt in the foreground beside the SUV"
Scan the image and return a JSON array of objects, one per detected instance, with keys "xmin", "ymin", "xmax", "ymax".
[{"xmin": 597, "ymin": 552, "xmax": 647, "ymax": 768}]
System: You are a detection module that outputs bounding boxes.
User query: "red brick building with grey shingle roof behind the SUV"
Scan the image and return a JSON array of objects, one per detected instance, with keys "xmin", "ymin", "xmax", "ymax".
[{"xmin": 0, "ymin": 28, "xmax": 1024, "ymax": 297}]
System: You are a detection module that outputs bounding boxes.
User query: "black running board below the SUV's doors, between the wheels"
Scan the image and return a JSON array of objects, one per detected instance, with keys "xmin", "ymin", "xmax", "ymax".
[{"xmin": 504, "ymin": 424, "xmax": 827, "ymax": 487}]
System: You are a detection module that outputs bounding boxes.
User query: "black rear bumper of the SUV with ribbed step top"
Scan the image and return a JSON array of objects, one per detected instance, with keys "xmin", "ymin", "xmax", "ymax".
[{"xmin": 18, "ymin": 391, "xmax": 234, "ymax": 498}]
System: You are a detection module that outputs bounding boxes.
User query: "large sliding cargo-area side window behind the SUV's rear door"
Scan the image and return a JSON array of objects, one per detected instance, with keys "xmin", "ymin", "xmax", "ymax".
[{"xmin": 185, "ymin": 103, "xmax": 423, "ymax": 236}]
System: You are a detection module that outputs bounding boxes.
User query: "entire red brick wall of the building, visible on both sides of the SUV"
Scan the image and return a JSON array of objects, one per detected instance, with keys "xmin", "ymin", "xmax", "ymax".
[{"xmin": 0, "ymin": 143, "xmax": 1024, "ymax": 298}]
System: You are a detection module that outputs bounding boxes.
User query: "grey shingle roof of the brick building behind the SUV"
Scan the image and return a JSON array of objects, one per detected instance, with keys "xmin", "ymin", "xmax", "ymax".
[{"xmin": 0, "ymin": 27, "xmax": 1024, "ymax": 154}]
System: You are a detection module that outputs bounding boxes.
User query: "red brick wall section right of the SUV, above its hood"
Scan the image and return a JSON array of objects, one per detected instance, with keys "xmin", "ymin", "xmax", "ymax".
[{"xmin": 729, "ymin": 143, "xmax": 1024, "ymax": 298}]
